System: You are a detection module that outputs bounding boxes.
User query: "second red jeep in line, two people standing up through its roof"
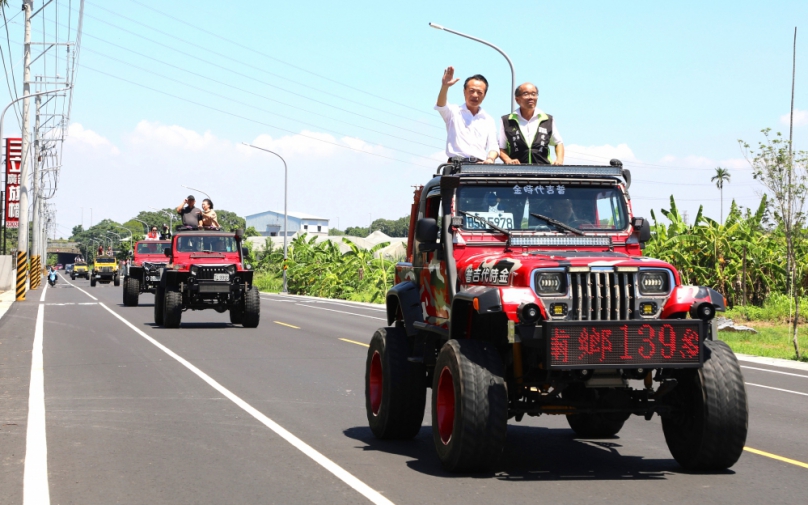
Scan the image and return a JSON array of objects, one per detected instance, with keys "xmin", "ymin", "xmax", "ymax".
[{"xmin": 154, "ymin": 230, "xmax": 261, "ymax": 328}]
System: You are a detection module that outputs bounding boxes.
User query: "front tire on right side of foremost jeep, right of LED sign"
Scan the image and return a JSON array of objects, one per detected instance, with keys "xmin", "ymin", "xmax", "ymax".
[{"xmin": 662, "ymin": 340, "xmax": 749, "ymax": 471}]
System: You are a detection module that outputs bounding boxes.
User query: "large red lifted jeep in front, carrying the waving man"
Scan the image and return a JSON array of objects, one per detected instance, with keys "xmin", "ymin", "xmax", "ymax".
[{"xmin": 365, "ymin": 160, "xmax": 747, "ymax": 471}]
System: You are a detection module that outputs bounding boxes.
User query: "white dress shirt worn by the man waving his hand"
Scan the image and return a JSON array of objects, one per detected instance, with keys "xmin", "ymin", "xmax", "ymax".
[{"xmin": 435, "ymin": 103, "xmax": 499, "ymax": 160}]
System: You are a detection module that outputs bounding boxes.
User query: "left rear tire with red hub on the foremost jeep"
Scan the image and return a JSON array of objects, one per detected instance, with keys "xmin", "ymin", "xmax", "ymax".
[{"xmin": 365, "ymin": 328, "xmax": 426, "ymax": 439}]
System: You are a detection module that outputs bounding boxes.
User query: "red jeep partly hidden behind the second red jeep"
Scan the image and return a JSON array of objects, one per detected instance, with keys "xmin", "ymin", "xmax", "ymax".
[{"xmin": 123, "ymin": 240, "xmax": 171, "ymax": 307}]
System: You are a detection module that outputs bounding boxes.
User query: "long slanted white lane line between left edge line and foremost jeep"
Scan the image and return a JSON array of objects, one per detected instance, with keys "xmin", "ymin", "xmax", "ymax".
[{"xmin": 96, "ymin": 303, "xmax": 393, "ymax": 505}]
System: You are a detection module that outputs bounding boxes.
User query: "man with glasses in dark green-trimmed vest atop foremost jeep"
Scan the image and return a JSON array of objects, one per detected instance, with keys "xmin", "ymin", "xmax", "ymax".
[{"xmin": 499, "ymin": 82, "xmax": 564, "ymax": 165}]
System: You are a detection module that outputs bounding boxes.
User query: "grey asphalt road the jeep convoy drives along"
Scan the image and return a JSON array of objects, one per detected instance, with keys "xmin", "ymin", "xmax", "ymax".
[{"xmin": 0, "ymin": 278, "xmax": 808, "ymax": 505}]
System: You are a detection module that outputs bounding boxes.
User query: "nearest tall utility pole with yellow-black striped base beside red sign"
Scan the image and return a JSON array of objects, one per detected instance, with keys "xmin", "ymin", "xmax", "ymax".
[{"xmin": 16, "ymin": 0, "xmax": 34, "ymax": 302}]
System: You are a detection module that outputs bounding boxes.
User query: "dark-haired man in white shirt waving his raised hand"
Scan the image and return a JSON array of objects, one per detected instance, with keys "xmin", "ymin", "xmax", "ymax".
[{"xmin": 435, "ymin": 67, "xmax": 499, "ymax": 163}]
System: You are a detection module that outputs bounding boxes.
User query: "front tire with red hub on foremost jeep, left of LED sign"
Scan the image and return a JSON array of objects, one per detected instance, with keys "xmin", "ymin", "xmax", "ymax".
[{"xmin": 432, "ymin": 340, "xmax": 508, "ymax": 472}]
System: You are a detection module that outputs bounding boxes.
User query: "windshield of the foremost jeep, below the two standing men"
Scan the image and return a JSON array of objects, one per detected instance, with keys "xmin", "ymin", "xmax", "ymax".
[{"xmin": 457, "ymin": 181, "xmax": 628, "ymax": 232}]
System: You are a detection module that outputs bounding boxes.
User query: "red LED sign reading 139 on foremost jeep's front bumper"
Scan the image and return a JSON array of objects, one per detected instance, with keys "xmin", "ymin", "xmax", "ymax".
[{"xmin": 544, "ymin": 319, "xmax": 704, "ymax": 369}]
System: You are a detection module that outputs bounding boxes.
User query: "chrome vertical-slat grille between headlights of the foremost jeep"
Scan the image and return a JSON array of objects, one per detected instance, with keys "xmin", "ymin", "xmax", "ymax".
[{"xmin": 570, "ymin": 271, "xmax": 637, "ymax": 321}]
